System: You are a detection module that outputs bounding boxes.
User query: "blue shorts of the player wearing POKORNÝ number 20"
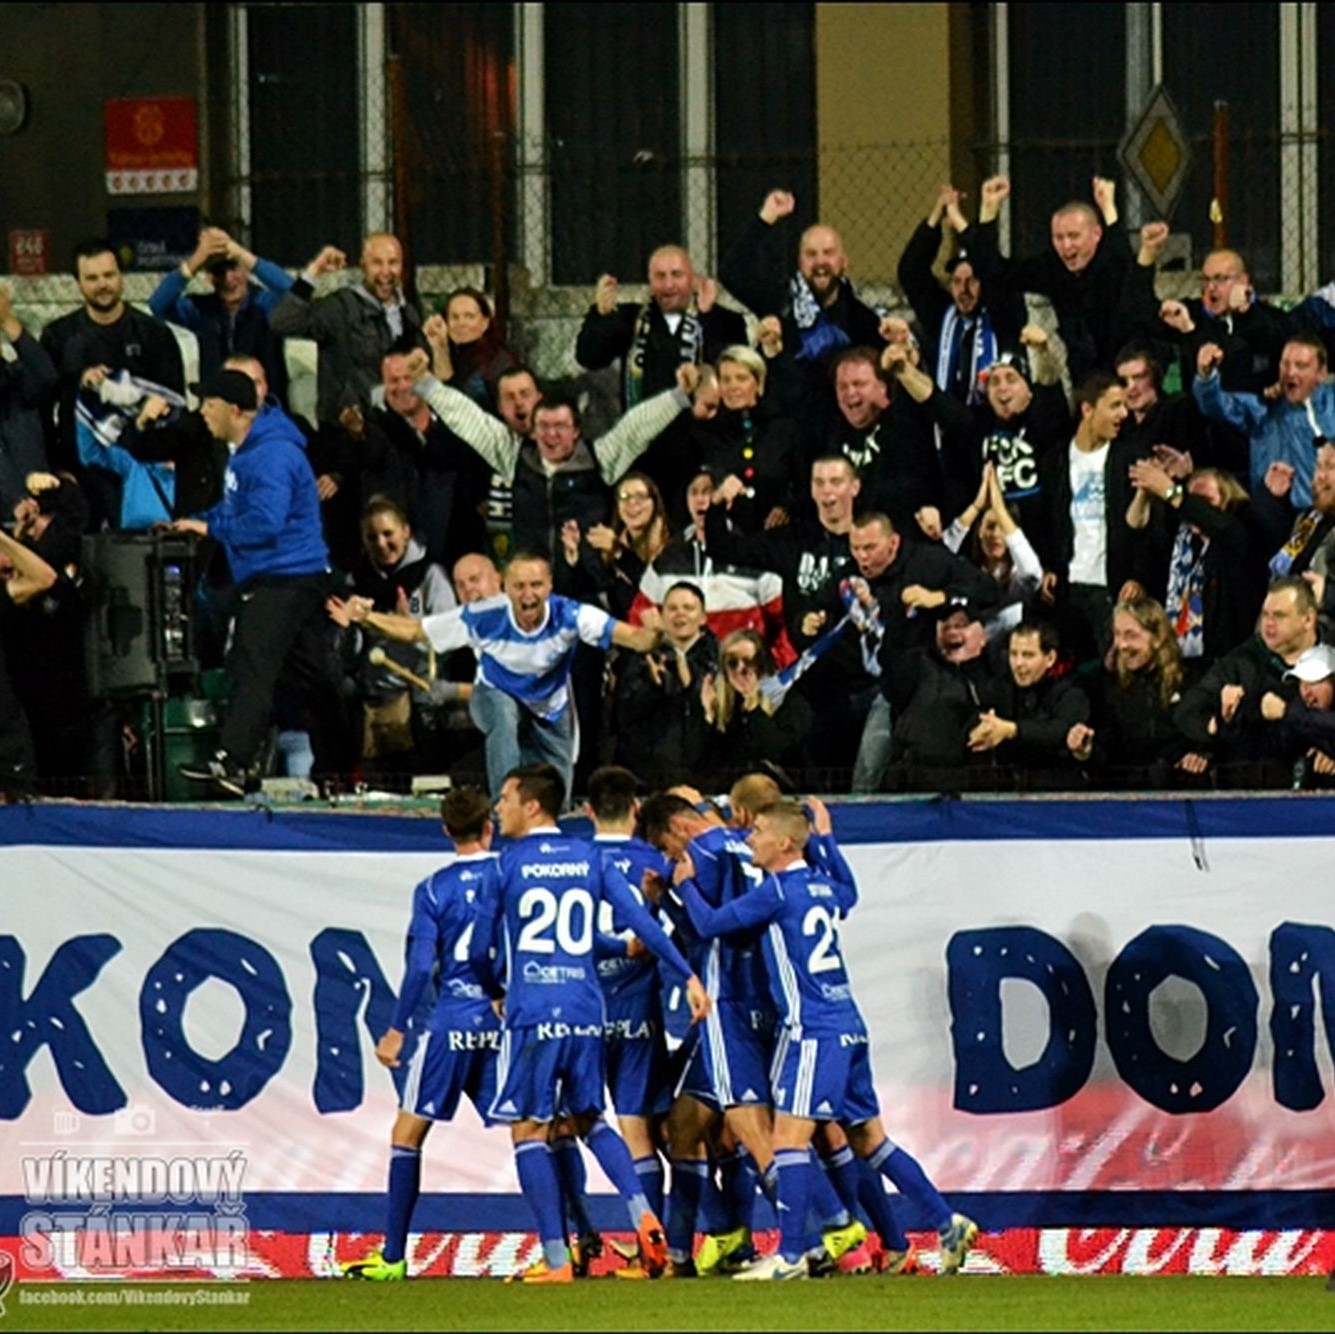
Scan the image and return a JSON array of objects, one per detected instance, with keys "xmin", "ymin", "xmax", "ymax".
[{"xmin": 491, "ymin": 1022, "xmax": 603, "ymax": 1124}]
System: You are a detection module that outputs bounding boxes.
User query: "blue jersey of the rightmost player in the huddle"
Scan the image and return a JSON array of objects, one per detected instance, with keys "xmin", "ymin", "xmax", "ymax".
[{"xmin": 684, "ymin": 859, "xmax": 865, "ymax": 1032}]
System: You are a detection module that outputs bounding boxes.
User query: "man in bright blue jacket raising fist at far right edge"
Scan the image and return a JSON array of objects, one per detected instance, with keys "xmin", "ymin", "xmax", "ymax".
[{"xmin": 1192, "ymin": 334, "xmax": 1335, "ymax": 509}]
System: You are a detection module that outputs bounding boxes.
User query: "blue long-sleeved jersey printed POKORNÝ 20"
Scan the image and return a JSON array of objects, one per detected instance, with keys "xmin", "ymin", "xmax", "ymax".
[{"xmin": 471, "ymin": 827, "xmax": 690, "ymax": 1032}]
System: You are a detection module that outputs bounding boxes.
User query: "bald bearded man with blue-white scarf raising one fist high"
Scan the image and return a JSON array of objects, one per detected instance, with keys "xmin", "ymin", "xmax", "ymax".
[{"xmin": 718, "ymin": 190, "xmax": 881, "ymax": 401}]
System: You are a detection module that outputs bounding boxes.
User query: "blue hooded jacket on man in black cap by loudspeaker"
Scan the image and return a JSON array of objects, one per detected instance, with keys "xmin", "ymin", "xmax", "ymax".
[{"xmin": 199, "ymin": 405, "xmax": 330, "ymax": 584}]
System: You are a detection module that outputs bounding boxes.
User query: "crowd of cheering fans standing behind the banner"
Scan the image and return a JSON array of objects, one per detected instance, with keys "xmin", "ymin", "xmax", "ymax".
[{"xmin": 0, "ymin": 176, "xmax": 1335, "ymax": 796}]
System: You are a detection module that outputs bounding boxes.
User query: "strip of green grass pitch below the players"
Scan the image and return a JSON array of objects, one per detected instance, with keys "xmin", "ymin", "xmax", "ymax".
[{"xmin": 0, "ymin": 1275, "xmax": 1335, "ymax": 1334}]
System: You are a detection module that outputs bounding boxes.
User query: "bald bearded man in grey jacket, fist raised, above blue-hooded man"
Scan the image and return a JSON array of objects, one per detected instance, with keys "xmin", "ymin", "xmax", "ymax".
[{"xmin": 270, "ymin": 232, "xmax": 427, "ymax": 425}]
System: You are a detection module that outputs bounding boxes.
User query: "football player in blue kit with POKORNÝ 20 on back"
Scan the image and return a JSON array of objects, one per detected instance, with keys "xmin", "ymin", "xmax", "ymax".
[{"xmin": 470, "ymin": 764, "xmax": 709, "ymax": 1283}]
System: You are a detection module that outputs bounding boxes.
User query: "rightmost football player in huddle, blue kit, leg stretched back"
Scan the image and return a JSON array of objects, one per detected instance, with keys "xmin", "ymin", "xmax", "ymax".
[{"xmin": 678, "ymin": 801, "xmax": 977, "ymax": 1279}]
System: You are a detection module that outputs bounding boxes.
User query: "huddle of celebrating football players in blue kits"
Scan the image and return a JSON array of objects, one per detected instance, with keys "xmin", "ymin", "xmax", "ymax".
[{"xmin": 343, "ymin": 764, "xmax": 977, "ymax": 1283}]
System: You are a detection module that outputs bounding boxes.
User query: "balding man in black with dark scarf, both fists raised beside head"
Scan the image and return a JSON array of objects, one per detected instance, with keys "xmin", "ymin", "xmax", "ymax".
[{"xmin": 575, "ymin": 246, "xmax": 746, "ymax": 409}]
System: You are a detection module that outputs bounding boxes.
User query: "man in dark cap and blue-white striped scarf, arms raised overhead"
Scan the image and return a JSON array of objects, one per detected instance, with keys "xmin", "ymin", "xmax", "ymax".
[{"xmin": 898, "ymin": 186, "xmax": 1027, "ymax": 405}]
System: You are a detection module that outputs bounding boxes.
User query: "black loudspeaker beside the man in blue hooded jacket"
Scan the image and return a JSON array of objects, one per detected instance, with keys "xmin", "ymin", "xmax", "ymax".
[{"xmin": 83, "ymin": 533, "xmax": 199, "ymax": 698}]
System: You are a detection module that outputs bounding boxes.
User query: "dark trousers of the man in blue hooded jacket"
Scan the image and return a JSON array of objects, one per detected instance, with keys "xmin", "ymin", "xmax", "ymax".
[{"xmin": 219, "ymin": 574, "xmax": 348, "ymax": 774}]
